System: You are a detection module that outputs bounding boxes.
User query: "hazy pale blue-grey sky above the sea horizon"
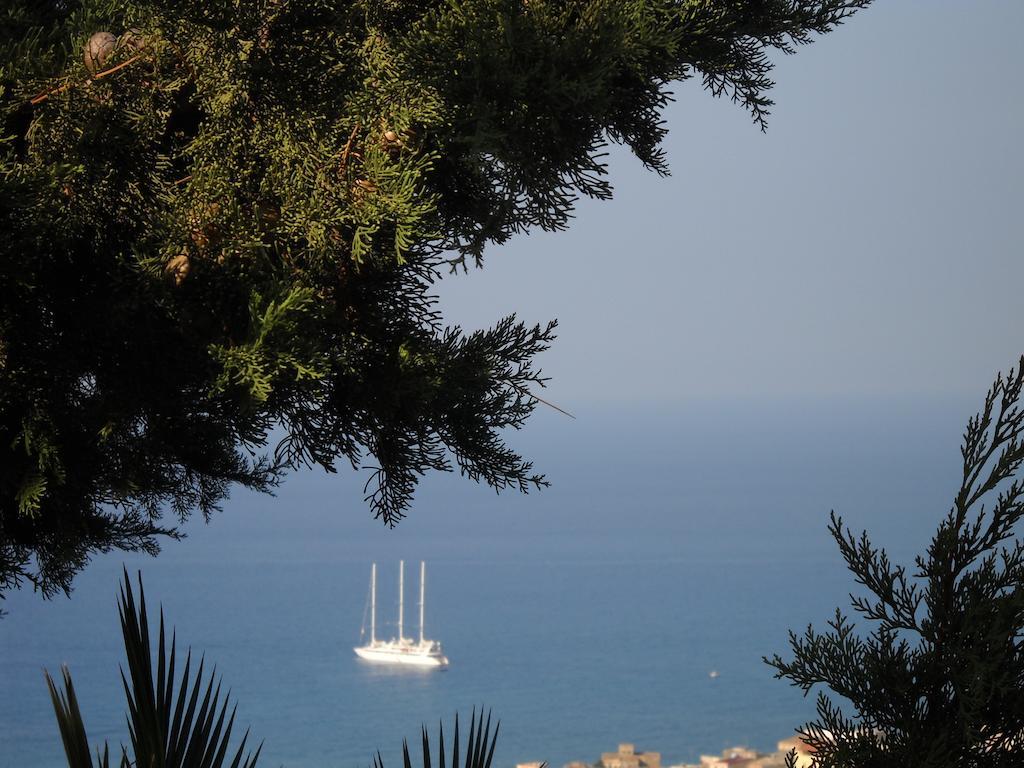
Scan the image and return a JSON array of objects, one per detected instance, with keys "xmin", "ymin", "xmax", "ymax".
[{"xmin": 440, "ymin": 0, "xmax": 1024, "ymax": 409}]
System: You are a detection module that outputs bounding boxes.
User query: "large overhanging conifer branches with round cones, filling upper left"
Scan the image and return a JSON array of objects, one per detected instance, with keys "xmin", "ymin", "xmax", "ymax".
[{"xmin": 0, "ymin": 0, "xmax": 867, "ymax": 594}]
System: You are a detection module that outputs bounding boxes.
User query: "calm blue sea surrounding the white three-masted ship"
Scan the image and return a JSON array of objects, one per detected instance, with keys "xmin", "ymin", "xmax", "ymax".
[{"xmin": 0, "ymin": 398, "xmax": 976, "ymax": 768}]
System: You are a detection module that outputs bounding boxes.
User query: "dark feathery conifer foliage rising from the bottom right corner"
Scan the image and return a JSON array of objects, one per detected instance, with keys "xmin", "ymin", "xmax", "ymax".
[{"xmin": 765, "ymin": 357, "xmax": 1024, "ymax": 768}]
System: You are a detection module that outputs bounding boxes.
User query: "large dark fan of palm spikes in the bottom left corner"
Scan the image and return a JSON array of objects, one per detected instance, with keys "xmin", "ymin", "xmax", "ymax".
[{"xmin": 46, "ymin": 570, "xmax": 262, "ymax": 768}]
